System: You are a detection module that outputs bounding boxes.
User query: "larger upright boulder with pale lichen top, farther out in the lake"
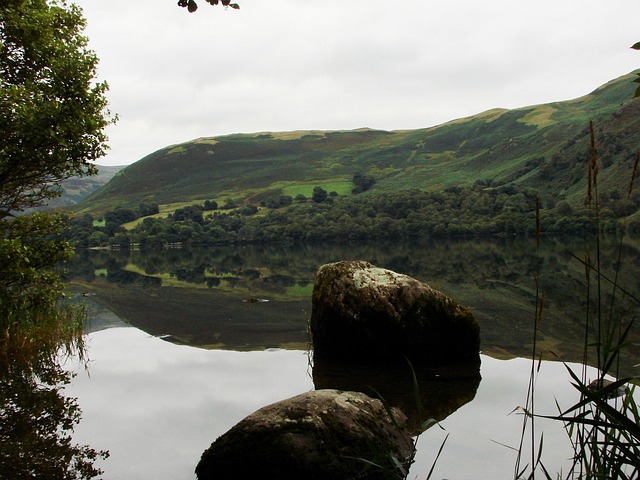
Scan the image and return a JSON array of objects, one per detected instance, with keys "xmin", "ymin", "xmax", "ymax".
[{"xmin": 311, "ymin": 261, "xmax": 480, "ymax": 364}]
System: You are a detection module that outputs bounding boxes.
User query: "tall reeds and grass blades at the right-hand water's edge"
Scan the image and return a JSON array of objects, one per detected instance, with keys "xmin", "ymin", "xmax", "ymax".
[{"xmin": 515, "ymin": 123, "xmax": 640, "ymax": 480}]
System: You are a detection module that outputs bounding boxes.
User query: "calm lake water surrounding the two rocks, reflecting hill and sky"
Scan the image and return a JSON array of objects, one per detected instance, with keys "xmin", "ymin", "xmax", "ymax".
[{"xmin": 65, "ymin": 238, "xmax": 640, "ymax": 480}]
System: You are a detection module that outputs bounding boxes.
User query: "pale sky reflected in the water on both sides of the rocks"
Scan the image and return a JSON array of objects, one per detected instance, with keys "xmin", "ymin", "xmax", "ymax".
[{"xmin": 66, "ymin": 328, "xmax": 592, "ymax": 480}]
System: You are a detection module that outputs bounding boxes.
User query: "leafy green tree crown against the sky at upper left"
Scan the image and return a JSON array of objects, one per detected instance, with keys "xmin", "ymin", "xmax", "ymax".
[{"xmin": 0, "ymin": 0, "xmax": 112, "ymax": 216}]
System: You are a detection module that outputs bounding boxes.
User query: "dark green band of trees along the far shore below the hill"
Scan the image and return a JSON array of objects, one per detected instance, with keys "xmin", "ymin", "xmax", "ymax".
[{"xmin": 70, "ymin": 181, "xmax": 640, "ymax": 248}]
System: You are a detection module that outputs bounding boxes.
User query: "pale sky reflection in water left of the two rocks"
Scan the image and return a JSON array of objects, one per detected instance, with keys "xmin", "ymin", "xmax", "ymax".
[{"xmin": 66, "ymin": 328, "xmax": 313, "ymax": 480}]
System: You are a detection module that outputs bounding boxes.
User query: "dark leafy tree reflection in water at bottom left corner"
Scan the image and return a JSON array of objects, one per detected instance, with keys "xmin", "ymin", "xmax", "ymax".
[{"xmin": 0, "ymin": 362, "xmax": 107, "ymax": 480}]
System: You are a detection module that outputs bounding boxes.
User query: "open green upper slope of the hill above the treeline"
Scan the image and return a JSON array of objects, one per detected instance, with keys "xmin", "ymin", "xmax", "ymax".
[{"xmin": 78, "ymin": 72, "xmax": 640, "ymax": 213}]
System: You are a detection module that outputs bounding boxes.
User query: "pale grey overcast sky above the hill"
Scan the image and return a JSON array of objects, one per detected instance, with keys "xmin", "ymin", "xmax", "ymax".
[{"xmin": 76, "ymin": 0, "xmax": 640, "ymax": 165}]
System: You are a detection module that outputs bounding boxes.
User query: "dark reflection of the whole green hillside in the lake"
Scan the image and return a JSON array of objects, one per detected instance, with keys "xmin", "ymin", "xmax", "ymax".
[{"xmin": 65, "ymin": 238, "xmax": 640, "ymax": 372}]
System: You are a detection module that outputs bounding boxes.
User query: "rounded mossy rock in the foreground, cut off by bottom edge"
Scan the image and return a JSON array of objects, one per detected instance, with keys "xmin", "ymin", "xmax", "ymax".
[{"xmin": 196, "ymin": 390, "xmax": 414, "ymax": 480}]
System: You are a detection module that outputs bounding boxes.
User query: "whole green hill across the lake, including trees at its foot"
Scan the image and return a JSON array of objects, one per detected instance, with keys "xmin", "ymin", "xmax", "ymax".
[{"xmin": 71, "ymin": 74, "xmax": 640, "ymax": 248}]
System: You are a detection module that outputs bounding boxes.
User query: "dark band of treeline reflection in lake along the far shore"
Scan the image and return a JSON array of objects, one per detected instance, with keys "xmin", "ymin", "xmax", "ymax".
[{"xmin": 72, "ymin": 238, "xmax": 640, "ymax": 293}]
